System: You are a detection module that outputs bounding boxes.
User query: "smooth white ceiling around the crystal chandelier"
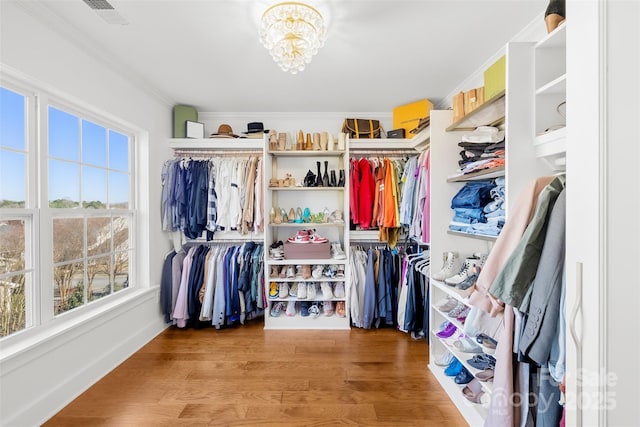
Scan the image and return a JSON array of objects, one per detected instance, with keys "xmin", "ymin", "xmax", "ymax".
[{"xmin": 18, "ymin": 0, "xmax": 547, "ymax": 112}]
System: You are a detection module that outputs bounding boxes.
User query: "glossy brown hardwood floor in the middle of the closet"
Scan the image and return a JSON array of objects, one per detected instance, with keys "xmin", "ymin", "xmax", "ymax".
[{"xmin": 44, "ymin": 319, "xmax": 466, "ymax": 427}]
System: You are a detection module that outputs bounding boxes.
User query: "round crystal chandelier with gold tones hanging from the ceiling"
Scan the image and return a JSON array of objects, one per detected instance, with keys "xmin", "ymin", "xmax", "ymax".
[{"xmin": 260, "ymin": 2, "xmax": 326, "ymax": 74}]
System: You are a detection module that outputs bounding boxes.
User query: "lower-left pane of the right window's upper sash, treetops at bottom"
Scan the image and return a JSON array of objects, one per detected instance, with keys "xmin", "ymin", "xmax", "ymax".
[{"xmin": 49, "ymin": 160, "xmax": 80, "ymax": 208}]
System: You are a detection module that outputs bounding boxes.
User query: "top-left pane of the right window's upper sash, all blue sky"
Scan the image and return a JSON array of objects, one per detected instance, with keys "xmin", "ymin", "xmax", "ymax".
[{"xmin": 48, "ymin": 107, "xmax": 80, "ymax": 160}]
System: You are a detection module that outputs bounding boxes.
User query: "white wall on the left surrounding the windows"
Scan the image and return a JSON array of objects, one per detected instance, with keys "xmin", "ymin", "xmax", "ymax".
[{"xmin": 0, "ymin": 1, "xmax": 171, "ymax": 426}]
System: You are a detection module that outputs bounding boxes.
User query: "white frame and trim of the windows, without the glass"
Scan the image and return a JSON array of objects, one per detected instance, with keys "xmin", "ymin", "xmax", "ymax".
[{"xmin": 0, "ymin": 71, "xmax": 139, "ymax": 347}]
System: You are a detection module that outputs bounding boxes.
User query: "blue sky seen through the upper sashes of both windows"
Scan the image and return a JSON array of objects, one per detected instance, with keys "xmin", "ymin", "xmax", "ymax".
[{"xmin": 0, "ymin": 88, "xmax": 129, "ymax": 207}]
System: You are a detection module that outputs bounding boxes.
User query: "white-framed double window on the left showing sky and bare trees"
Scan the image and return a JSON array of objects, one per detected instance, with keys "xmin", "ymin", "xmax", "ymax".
[{"xmin": 0, "ymin": 79, "xmax": 135, "ymax": 338}]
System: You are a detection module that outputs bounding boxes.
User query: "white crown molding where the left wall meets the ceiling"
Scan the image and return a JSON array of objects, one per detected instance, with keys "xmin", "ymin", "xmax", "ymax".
[{"xmin": 14, "ymin": 1, "xmax": 174, "ymax": 107}]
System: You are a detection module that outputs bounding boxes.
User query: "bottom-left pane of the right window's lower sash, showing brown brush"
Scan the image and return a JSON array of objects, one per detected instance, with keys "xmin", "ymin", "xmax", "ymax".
[{"xmin": 53, "ymin": 262, "xmax": 84, "ymax": 314}]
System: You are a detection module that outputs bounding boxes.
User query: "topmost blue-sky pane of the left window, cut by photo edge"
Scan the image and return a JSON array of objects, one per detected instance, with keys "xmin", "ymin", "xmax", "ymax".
[{"xmin": 0, "ymin": 87, "xmax": 26, "ymax": 150}]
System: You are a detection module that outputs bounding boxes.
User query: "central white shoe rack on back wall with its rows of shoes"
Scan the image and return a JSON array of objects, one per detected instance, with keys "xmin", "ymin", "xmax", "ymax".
[{"xmin": 264, "ymin": 133, "xmax": 350, "ymax": 329}]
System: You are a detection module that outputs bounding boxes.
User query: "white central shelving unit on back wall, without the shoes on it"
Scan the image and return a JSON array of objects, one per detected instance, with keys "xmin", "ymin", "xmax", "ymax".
[{"xmin": 264, "ymin": 150, "xmax": 350, "ymax": 329}]
